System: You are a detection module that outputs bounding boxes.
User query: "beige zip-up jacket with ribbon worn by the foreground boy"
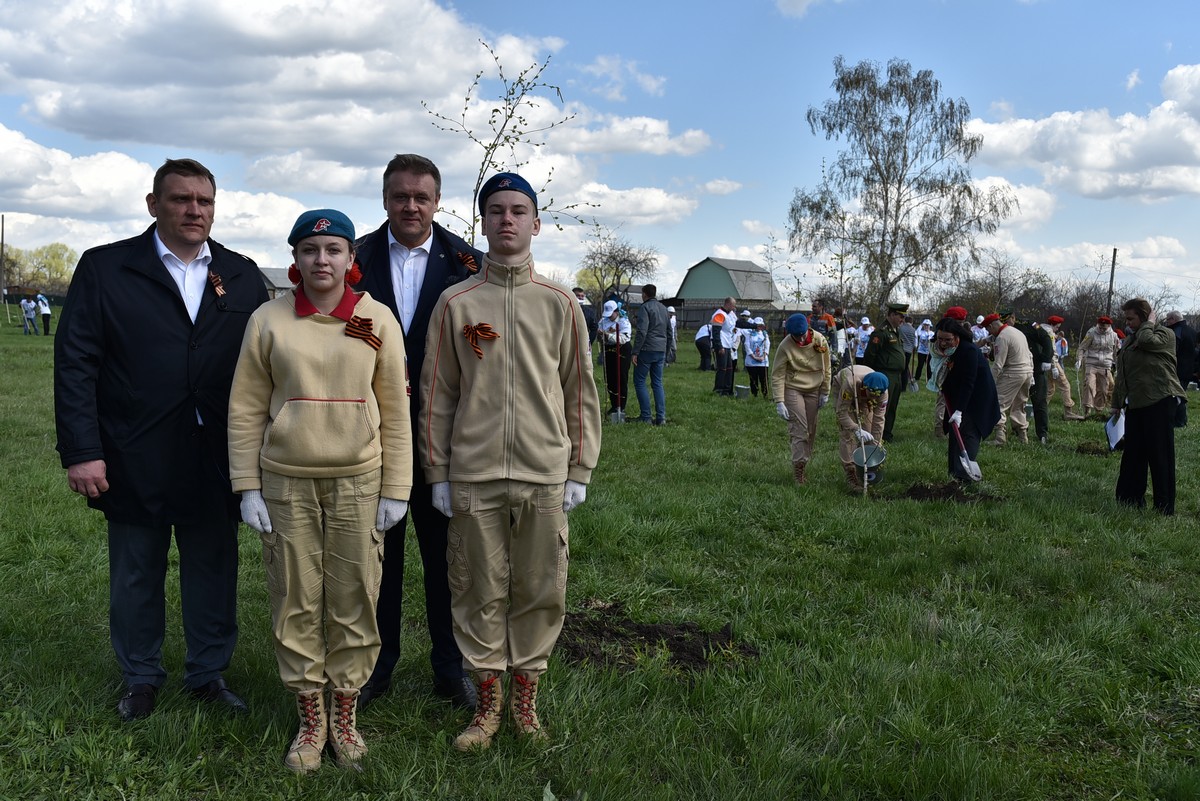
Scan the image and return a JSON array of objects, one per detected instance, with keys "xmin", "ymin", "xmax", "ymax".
[{"xmin": 418, "ymin": 258, "xmax": 609, "ymax": 484}]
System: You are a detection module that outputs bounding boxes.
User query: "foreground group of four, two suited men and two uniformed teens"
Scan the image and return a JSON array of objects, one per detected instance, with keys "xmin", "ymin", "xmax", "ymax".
[{"xmin": 55, "ymin": 155, "xmax": 604, "ymax": 772}]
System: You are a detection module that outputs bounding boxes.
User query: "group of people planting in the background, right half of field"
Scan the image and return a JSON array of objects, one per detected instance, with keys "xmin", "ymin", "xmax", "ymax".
[{"xmin": 772, "ymin": 299, "xmax": 1195, "ymax": 514}]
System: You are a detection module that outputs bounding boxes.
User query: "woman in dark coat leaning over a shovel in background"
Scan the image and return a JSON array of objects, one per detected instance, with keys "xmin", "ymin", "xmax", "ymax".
[{"xmin": 935, "ymin": 318, "xmax": 1001, "ymax": 481}]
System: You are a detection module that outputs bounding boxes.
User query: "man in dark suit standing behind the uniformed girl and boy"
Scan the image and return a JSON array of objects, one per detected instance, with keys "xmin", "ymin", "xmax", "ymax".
[{"xmin": 355, "ymin": 153, "xmax": 484, "ymax": 709}]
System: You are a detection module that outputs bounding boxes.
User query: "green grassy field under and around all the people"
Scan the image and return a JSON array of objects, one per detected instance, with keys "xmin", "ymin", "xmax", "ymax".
[{"xmin": 0, "ymin": 320, "xmax": 1200, "ymax": 801}]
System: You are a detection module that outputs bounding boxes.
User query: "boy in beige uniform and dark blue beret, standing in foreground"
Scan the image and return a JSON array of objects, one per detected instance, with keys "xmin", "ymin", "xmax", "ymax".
[{"xmin": 418, "ymin": 173, "xmax": 600, "ymax": 751}]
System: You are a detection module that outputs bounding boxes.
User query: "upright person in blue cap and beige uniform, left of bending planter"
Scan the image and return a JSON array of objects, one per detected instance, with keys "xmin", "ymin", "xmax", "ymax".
[{"xmin": 770, "ymin": 314, "xmax": 830, "ymax": 484}]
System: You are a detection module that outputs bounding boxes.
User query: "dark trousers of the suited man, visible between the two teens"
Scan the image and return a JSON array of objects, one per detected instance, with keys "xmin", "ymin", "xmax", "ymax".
[{"xmin": 371, "ymin": 468, "xmax": 466, "ymax": 683}]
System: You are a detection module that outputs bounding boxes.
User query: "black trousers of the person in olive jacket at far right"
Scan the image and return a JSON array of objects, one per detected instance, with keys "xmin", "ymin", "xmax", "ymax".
[{"xmin": 1116, "ymin": 397, "xmax": 1177, "ymax": 514}]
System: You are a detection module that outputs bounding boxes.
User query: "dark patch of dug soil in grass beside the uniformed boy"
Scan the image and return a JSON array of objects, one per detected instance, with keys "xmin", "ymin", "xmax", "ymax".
[{"xmin": 556, "ymin": 600, "xmax": 758, "ymax": 671}]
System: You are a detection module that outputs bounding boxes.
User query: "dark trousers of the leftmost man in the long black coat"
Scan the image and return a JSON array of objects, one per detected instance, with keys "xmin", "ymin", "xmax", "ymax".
[{"xmin": 108, "ymin": 519, "xmax": 238, "ymax": 687}]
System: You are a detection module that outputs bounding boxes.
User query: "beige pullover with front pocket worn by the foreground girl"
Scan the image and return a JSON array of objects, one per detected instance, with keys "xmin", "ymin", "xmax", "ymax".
[{"xmin": 229, "ymin": 290, "xmax": 413, "ymax": 500}]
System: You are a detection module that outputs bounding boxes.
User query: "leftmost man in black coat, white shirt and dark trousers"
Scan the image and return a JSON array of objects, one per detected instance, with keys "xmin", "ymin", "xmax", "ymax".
[{"xmin": 54, "ymin": 159, "xmax": 266, "ymax": 721}]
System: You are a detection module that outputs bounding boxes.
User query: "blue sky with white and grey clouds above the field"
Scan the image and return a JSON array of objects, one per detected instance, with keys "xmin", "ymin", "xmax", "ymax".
[{"xmin": 0, "ymin": 0, "xmax": 1200, "ymax": 308}]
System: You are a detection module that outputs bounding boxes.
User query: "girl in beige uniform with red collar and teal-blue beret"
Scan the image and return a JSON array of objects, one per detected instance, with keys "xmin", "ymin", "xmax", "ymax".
[{"xmin": 229, "ymin": 209, "xmax": 413, "ymax": 772}]
